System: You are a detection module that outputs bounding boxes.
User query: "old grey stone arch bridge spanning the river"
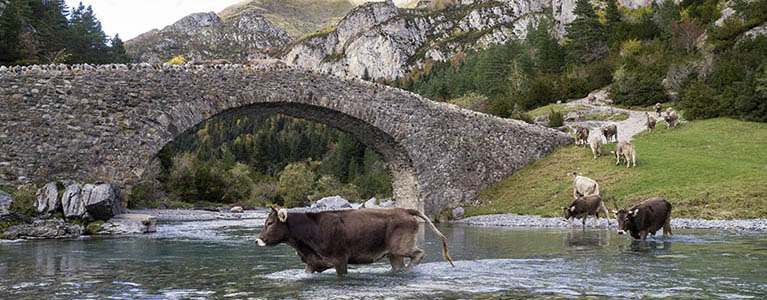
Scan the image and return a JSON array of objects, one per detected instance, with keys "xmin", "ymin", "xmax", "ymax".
[{"xmin": 0, "ymin": 64, "xmax": 571, "ymax": 216}]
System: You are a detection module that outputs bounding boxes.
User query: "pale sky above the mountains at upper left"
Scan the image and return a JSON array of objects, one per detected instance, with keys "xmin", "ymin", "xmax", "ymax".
[{"xmin": 66, "ymin": 0, "xmax": 414, "ymax": 41}]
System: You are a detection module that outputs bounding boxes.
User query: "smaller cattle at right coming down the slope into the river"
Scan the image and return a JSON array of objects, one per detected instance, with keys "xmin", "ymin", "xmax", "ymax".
[{"xmin": 562, "ymin": 103, "xmax": 679, "ymax": 240}]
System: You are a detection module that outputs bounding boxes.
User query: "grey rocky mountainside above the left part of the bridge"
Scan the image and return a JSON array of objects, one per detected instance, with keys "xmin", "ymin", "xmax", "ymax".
[{"xmin": 125, "ymin": 11, "xmax": 291, "ymax": 63}]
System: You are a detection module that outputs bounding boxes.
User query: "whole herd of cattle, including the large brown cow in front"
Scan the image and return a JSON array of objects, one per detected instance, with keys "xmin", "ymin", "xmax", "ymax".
[{"xmin": 256, "ymin": 104, "xmax": 679, "ymax": 277}]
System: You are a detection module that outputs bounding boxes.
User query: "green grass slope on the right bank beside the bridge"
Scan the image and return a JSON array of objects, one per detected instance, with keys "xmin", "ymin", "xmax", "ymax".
[{"xmin": 466, "ymin": 118, "xmax": 767, "ymax": 219}]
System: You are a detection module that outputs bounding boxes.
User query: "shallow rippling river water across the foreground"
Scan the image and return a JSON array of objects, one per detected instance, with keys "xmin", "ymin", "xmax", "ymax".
[{"xmin": 0, "ymin": 214, "xmax": 767, "ymax": 299}]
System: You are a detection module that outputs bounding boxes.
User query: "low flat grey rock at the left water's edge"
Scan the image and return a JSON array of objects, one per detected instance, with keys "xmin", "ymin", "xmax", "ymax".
[{"xmin": 3, "ymin": 219, "xmax": 83, "ymax": 240}]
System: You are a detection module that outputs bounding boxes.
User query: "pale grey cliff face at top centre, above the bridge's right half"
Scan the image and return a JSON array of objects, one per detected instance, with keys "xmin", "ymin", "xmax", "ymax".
[{"xmin": 283, "ymin": 0, "xmax": 548, "ymax": 79}]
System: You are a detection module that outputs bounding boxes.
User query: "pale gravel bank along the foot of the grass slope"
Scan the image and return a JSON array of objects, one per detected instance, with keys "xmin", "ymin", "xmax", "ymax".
[{"xmin": 453, "ymin": 214, "xmax": 767, "ymax": 232}]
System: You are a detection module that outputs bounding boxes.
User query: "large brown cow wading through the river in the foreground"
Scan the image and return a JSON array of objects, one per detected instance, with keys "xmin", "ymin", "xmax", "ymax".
[{"xmin": 256, "ymin": 206, "xmax": 455, "ymax": 276}]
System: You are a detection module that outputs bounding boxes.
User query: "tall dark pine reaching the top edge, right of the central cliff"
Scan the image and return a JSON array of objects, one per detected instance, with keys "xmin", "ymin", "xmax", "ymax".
[{"xmin": 565, "ymin": 0, "xmax": 606, "ymax": 62}]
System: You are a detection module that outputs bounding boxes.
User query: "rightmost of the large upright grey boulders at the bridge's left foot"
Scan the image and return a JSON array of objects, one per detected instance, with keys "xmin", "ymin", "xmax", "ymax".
[{"xmin": 82, "ymin": 183, "xmax": 122, "ymax": 221}]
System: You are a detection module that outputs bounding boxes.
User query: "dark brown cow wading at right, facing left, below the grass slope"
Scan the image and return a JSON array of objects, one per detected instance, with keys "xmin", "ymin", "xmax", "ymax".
[{"xmin": 613, "ymin": 197, "xmax": 671, "ymax": 240}]
